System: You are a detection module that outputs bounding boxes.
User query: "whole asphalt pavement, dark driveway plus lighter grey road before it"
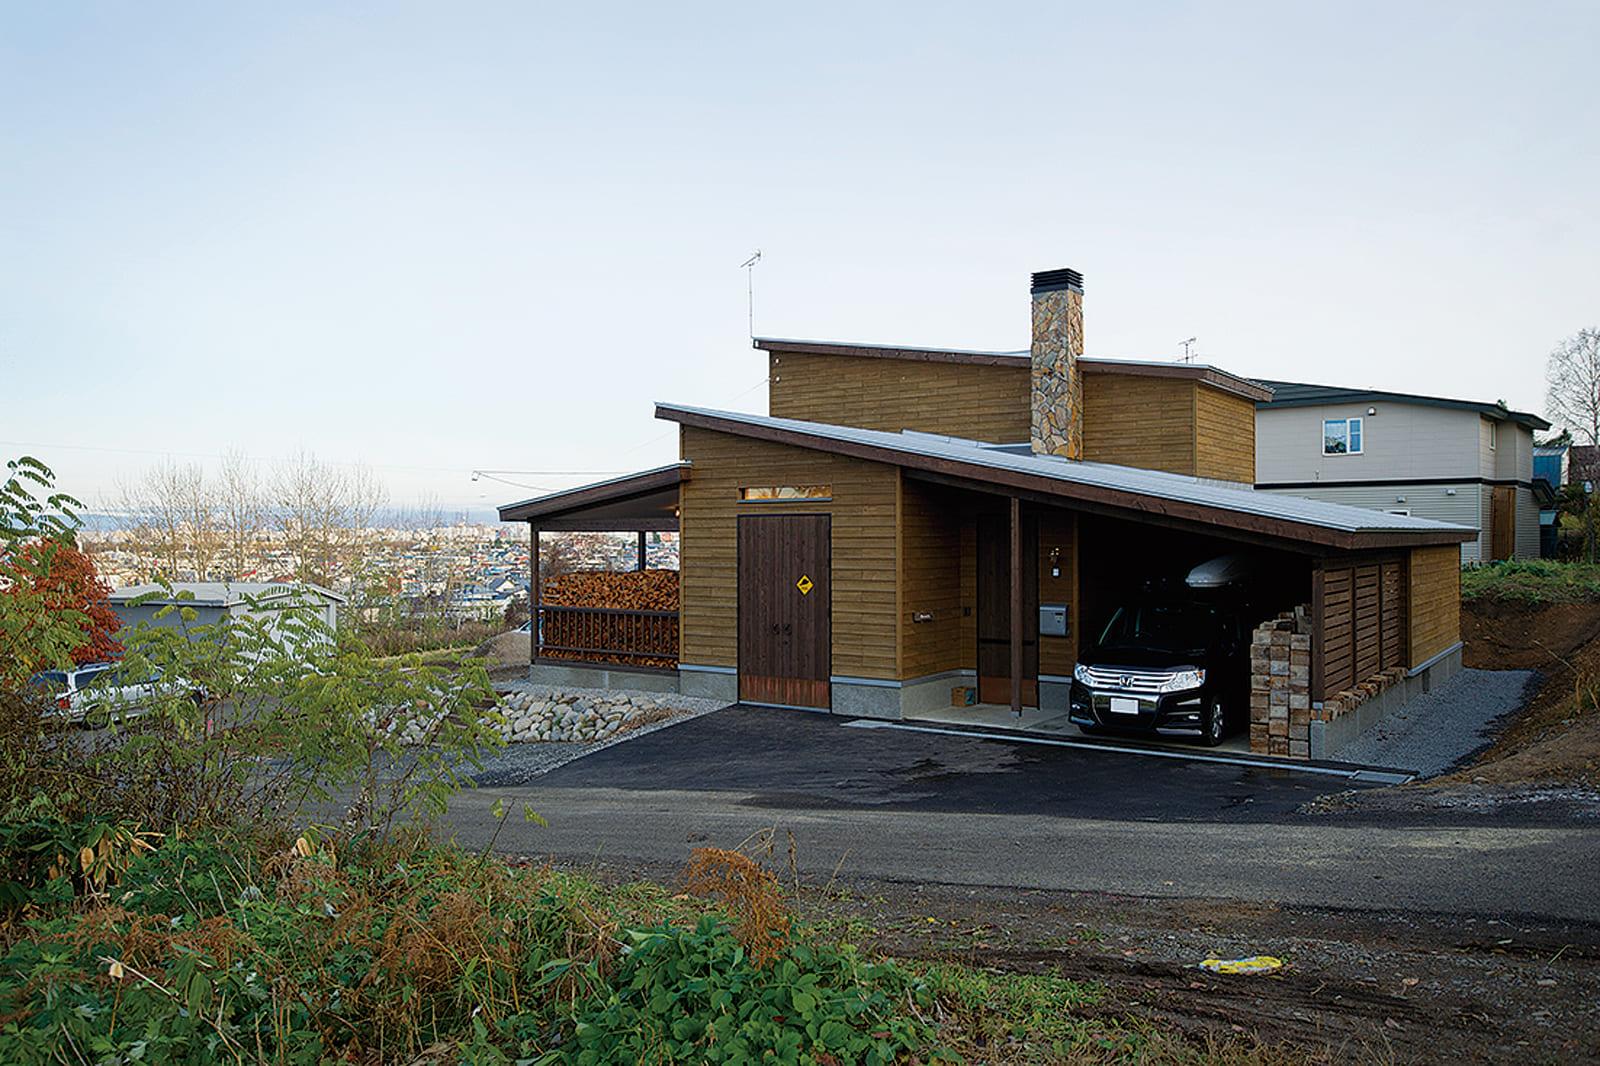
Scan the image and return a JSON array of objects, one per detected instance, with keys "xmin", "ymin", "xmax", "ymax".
[{"xmin": 448, "ymin": 706, "xmax": 1600, "ymax": 922}]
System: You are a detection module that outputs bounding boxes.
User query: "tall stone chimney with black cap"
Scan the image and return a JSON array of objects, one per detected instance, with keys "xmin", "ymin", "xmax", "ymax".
[{"xmin": 1029, "ymin": 269, "xmax": 1083, "ymax": 459}]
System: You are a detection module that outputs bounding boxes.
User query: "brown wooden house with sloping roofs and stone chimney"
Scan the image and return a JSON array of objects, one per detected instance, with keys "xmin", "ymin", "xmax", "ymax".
[{"xmin": 501, "ymin": 271, "xmax": 1475, "ymax": 745}]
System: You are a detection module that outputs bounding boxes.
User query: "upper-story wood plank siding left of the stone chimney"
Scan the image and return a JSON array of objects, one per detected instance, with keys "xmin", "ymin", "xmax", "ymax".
[{"xmin": 766, "ymin": 352, "xmax": 1029, "ymax": 443}]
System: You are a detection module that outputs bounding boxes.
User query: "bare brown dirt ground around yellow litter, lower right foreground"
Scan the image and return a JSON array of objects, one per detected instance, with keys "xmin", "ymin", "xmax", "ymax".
[{"xmin": 813, "ymin": 885, "xmax": 1600, "ymax": 1063}]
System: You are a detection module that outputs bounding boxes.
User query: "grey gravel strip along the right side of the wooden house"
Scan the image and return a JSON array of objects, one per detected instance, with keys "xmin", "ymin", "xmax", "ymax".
[{"xmin": 1331, "ymin": 671, "xmax": 1536, "ymax": 778}]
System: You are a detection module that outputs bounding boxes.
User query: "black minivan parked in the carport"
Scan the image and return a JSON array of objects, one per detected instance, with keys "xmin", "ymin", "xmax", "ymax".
[{"xmin": 1070, "ymin": 557, "xmax": 1251, "ymax": 744}]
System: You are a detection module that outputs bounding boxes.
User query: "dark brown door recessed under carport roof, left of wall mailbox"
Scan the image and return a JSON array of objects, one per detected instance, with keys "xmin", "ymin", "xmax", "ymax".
[{"xmin": 978, "ymin": 515, "xmax": 1038, "ymax": 707}]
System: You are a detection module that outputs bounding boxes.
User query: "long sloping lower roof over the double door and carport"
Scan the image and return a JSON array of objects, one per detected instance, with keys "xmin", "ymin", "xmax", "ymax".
[{"xmin": 656, "ymin": 403, "xmax": 1478, "ymax": 551}]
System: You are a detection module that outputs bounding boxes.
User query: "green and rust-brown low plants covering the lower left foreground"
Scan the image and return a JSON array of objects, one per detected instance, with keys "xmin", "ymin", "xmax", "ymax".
[{"xmin": 0, "ymin": 832, "xmax": 1324, "ymax": 1066}]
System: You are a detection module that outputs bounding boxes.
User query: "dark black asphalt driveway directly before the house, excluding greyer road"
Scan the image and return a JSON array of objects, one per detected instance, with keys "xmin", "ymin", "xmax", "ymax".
[{"xmin": 478, "ymin": 706, "xmax": 1388, "ymax": 823}]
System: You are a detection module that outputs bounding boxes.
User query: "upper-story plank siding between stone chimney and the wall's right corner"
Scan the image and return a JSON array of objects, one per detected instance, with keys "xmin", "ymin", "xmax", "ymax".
[{"xmin": 1083, "ymin": 373, "xmax": 1195, "ymax": 475}]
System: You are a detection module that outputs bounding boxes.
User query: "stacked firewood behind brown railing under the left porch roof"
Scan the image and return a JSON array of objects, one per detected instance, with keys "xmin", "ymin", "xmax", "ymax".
[{"xmin": 539, "ymin": 570, "xmax": 678, "ymax": 669}]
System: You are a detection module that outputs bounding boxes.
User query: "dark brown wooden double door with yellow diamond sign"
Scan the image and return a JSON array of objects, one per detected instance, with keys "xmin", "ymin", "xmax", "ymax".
[{"xmin": 739, "ymin": 514, "xmax": 832, "ymax": 709}]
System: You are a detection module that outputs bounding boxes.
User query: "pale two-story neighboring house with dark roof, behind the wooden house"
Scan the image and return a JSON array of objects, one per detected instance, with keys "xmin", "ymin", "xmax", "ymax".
[{"xmin": 1256, "ymin": 381, "xmax": 1550, "ymax": 563}]
